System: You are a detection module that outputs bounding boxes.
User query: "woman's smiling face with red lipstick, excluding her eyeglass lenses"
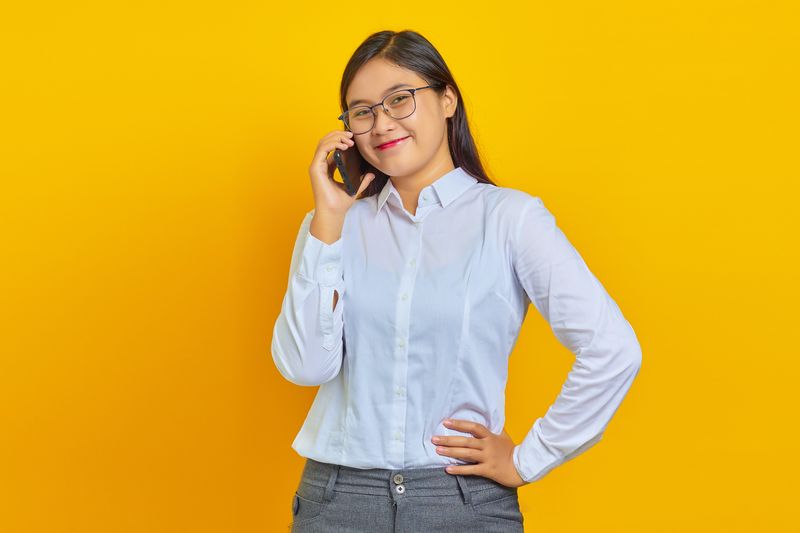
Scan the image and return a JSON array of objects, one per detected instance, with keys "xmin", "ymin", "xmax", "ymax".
[{"xmin": 345, "ymin": 58, "xmax": 457, "ymax": 176}]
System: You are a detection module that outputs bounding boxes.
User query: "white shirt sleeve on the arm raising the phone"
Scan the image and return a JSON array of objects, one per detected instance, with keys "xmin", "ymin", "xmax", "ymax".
[{"xmin": 272, "ymin": 209, "xmax": 345, "ymax": 386}]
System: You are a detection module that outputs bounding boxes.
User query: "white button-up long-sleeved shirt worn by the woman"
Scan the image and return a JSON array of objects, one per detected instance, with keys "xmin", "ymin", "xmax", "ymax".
[{"xmin": 272, "ymin": 167, "xmax": 641, "ymax": 482}]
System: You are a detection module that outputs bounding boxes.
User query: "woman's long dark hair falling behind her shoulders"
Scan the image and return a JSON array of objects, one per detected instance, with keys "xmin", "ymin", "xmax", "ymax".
[{"xmin": 340, "ymin": 30, "xmax": 496, "ymax": 198}]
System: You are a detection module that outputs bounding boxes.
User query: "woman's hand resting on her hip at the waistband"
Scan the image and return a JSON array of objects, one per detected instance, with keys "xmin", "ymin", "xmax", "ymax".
[{"xmin": 431, "ymin": 419, "xmax": 528, "ymax": 487}]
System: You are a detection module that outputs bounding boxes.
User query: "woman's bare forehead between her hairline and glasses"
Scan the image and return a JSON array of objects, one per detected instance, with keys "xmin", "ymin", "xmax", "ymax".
[{"xmin": 345, "ymin": 58, "xmax": 427, "ymax": 107}]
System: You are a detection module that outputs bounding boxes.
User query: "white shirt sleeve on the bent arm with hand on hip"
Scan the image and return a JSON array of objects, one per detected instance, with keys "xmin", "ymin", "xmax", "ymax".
[{"xmin": 512, "ymin": 197, "xmax": 642, "ymax": 482}]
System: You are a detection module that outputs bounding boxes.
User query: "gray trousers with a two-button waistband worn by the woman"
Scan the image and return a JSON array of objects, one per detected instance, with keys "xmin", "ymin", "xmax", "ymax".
[{"xmin": 289, "ymin": 458, "xmax": 524, "ymax": 533}]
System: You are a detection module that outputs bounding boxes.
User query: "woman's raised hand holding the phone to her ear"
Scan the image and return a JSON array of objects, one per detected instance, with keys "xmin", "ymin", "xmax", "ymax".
[{"xmin": 308, "ymin": 130, "xmax": 375, "ymax": 217}]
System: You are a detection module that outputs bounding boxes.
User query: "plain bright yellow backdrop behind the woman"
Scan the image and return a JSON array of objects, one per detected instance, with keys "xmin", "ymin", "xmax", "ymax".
[{"xmin": 0, "ymin": 0, "xmax": 800, "ymax": 533}]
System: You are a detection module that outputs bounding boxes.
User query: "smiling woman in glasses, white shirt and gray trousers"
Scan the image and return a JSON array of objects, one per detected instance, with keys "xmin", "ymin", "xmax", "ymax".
[{"xmin": 272, "ymin": 31, "xmax": 641, "ymax": 533}]
